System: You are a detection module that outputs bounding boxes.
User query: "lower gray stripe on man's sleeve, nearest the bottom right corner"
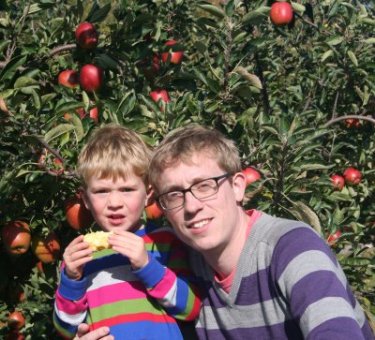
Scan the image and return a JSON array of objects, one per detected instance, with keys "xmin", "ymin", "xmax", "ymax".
[{"xmin": 300, "ymin": 297, "xmax": 355, "ymax": 338}]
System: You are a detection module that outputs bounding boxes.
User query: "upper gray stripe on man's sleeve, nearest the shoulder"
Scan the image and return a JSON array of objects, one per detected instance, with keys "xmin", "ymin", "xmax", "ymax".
[{"xmin": 278, "ymin": 250, "xmax": 346, "ymax": 297}]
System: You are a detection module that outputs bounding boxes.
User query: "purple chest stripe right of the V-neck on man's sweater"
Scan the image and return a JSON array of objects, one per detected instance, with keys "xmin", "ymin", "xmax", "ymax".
[{"xmin": 235, "ymin": 268, "xmax": 277, "ymax": 305}]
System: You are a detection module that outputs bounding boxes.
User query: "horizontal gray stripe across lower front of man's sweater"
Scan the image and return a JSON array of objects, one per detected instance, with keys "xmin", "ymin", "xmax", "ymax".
[{"xmin": 197, "ymin": 300, "xmax": 286, "ymax": 330}]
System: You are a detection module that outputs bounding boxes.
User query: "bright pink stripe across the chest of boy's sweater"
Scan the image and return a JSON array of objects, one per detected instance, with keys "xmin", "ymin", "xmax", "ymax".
[{"xmin": 87, "ymin": 281, "xmax": 146, "ymax": 308}]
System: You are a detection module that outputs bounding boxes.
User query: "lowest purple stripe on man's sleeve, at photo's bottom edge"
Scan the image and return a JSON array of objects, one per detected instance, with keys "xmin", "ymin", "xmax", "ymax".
[{"xmin": 306, "ymin": 318, "xmax": 374, "ymax": 340}]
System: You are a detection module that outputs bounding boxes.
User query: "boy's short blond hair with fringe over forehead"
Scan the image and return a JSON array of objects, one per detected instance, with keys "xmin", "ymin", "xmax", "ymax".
[{"xmin": 77, "ymin": 124, "xmax": 151, "ymax": 187}]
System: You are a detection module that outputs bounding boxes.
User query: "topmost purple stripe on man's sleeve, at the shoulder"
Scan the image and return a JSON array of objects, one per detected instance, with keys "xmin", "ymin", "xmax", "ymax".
[{"xmin": 271, "ymin": 227, "xmax": 337, "ymax": 280}]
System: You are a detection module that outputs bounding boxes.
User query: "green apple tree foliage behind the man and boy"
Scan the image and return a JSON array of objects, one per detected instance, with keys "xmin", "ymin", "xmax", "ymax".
[{"xmin": 0, "ymin": 0, "xmax": 375, "ymax": 339}]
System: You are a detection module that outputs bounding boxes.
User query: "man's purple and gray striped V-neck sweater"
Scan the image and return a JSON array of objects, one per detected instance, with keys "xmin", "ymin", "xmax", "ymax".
[{"xmin": 191, "ymin": 213, "xmax": 374, "ymax": 340}]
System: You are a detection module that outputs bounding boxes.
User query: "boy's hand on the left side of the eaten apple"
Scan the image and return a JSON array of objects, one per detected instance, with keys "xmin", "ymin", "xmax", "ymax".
[{"xmin": 63, "ymin": 235, "xmax": 92, "ymax": 280}]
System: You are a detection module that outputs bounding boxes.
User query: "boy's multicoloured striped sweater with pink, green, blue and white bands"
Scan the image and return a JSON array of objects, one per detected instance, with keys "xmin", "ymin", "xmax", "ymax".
[{"xmin": 53, "ymin": 223, "xmax": 200, "ymax": 340}]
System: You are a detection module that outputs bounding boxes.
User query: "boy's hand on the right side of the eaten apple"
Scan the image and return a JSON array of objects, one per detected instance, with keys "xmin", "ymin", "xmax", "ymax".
[{"xmin": 108, "ymin": 230, "xmax": 148, "ymax": 270}]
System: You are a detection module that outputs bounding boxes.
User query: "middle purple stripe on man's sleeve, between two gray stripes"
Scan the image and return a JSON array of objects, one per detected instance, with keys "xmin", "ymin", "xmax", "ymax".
[{"xmin": 289, "ymin": 270, "xmax": 348, "ymax": 318}]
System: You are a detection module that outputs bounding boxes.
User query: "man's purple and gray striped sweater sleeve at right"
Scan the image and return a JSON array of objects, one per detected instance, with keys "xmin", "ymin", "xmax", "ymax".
[{"xmin": 271, "ymin": 227, "xmax": 371, "ymax": 340}]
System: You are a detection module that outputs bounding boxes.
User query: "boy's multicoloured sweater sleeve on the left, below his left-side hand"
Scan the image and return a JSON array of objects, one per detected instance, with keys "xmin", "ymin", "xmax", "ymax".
[{"xmin": 53, "ymin": 269, "xmax": 87, "ymax": 339}]
